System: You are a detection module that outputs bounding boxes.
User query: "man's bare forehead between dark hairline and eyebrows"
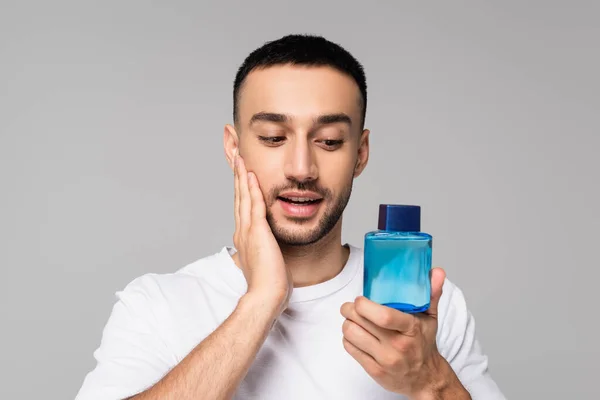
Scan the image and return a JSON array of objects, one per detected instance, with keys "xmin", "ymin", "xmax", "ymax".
[{"xmin": 238, "ymin": 65, "xmax": 361, "ymax": 124}]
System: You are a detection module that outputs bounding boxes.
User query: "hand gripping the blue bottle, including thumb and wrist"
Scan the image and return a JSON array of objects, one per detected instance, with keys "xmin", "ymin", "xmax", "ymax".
[{"xmin": 341, "ymin": 268, "xmax": 470, "ymax": 399}]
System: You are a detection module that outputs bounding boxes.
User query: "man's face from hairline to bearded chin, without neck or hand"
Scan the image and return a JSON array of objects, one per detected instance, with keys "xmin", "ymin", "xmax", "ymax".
[{"xmin": 230, "ymin": 65, "xmax": 368, "ymax": 246}]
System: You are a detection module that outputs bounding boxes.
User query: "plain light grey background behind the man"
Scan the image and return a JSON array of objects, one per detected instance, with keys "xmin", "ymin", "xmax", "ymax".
[{"xmin": 0, "ymin": 1, "xmax": 600, "ymax": 399}]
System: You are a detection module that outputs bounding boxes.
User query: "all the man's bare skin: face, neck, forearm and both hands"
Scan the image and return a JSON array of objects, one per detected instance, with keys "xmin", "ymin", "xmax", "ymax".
[{"xmin": 133, "ymin": 66, "xmax": 470, "ymax": 400}]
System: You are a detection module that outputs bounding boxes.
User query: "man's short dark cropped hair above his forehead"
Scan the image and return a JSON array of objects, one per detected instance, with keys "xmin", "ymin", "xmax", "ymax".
[{"xmin": 233, "ymin": 34, "xmax": 367, "ymax": 130}]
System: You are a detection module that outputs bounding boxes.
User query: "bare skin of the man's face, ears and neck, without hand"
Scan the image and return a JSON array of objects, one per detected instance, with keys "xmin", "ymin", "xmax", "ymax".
[{"xmin": 224, "ymin": 66, "xmax": 369, "ymax": 287}]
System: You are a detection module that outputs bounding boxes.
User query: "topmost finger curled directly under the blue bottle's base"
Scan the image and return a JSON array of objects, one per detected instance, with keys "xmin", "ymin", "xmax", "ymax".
[{"xmin": 354, "ymin": 296, "xmax": 416, "ymax": 334}]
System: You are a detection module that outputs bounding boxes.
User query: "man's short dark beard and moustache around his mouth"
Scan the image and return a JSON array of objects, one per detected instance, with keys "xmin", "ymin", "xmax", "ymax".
[{"xmin": 266, "ymin": 177, "xmax": 354, "ymax": 246}]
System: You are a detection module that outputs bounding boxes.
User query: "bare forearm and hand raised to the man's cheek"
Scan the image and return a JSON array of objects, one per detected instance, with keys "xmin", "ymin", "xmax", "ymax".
[{"xmin": 133, "ymin": 156, "xmax": 293, "ymax": 400}]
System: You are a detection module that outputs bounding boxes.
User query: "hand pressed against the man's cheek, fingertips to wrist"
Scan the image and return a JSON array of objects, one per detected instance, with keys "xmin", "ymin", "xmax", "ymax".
[{"xmin": 233, "ymin": 154, "xmax": 293, "ymax": 316}]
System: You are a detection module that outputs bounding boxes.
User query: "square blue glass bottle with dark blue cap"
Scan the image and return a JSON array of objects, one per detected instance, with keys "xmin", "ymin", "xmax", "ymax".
[{"xmin": 363, "ymin": 204, "xmax": 432, "ymax": 313}]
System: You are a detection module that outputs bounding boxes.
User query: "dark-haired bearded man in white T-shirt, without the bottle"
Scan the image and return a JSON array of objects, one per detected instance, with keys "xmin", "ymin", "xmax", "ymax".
[{"xmin": 77, "ymin": 35, "xmax": 504, "ymax": 400}]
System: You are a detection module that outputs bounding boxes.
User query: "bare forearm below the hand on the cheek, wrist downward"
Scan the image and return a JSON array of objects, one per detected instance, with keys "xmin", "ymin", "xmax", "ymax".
[{"xmin": 130, "ymin": 294, "xmax": 279, "ymax": 400}]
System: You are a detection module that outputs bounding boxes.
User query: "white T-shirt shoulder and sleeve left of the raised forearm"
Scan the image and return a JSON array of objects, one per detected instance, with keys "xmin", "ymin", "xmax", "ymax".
[{"xmin": 77, "ymin": 248, "xmax": 241, "ymax": 400}]
